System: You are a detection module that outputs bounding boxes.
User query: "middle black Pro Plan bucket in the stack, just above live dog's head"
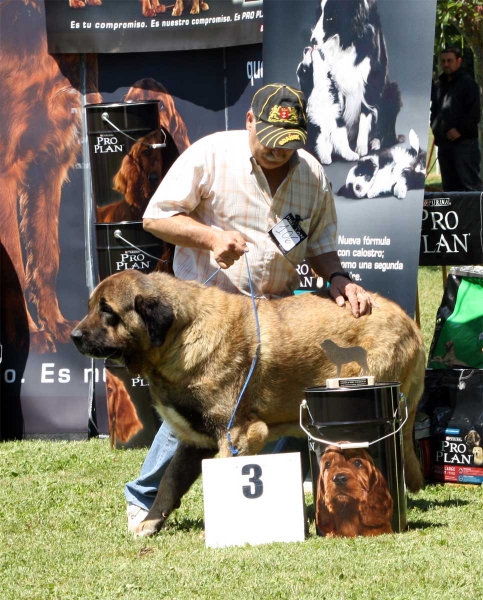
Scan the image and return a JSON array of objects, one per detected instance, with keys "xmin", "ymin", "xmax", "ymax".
[{"xmin": 95, "ymin": 221, "xmax": 174, "ymax": 280}]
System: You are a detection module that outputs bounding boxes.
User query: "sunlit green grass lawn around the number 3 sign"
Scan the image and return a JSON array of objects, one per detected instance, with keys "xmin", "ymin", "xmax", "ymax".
[{"xmin": 0, "ymin": 267, "xmax": 483, "ymax": 600}]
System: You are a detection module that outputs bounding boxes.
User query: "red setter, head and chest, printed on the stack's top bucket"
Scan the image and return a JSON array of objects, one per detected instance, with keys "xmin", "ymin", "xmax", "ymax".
[{"xmin": 96, "ymin": 129, "xmax": 179, "ymax": 223}]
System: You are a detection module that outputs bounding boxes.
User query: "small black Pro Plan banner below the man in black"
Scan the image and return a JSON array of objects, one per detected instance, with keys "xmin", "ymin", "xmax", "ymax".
[{"xmin": 419, "ymin": 192, "xmax": 483, "ymax": 266}]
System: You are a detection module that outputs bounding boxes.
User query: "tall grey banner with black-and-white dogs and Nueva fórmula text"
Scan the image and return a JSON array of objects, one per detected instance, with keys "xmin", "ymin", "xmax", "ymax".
[{"xmin": 263, "ymin": 0, "xmax": 436, "ymax": 314}]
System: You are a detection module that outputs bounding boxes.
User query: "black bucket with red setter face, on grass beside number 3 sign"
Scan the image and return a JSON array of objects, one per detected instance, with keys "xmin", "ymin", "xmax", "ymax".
[{"xmin": 300, "ymin": 382, "xmax": 407, "ymax": 537}]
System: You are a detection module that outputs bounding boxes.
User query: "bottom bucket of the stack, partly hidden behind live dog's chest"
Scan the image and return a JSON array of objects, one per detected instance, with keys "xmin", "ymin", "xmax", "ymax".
[{"xmin": 105, "ymin": 360, "xmax": 161, "ymax": 448}]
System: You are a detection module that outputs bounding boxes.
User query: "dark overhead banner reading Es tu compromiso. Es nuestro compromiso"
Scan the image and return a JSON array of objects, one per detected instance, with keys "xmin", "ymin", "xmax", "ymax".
[{"xmin": 45, "ymin": 0, "xmax": 263, "ymax": 54}]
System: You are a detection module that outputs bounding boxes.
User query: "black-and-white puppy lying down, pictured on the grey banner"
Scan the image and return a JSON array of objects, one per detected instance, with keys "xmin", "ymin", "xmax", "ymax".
[{"xmin": 337, "ymin": 129, "xmax": 426, "ymax": 199}]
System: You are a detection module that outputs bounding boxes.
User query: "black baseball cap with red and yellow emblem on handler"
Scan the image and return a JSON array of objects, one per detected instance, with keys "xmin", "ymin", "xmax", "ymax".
[{"xmin": 252, "ymin": 83, "xmax": 307, "ymax": 150}]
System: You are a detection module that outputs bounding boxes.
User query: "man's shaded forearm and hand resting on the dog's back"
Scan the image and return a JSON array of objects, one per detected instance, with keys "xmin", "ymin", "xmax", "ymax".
[{"xmin": 307, "ymin": 252, "xmax": 377, "ymax": 318}]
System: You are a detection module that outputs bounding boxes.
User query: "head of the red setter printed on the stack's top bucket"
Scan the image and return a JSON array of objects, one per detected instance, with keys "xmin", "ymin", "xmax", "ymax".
[{"xmin": 114, "ymin": 129, "xmax": 179, "ymax": 213}]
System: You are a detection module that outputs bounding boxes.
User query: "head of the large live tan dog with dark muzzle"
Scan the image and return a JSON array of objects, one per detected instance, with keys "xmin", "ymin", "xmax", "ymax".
[{"xmin": 71, "ymin": 270, "xmax": 174, "ymax": 369}]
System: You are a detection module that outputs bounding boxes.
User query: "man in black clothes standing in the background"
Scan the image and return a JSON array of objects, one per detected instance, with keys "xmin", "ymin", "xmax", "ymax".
[{"xmin": 431, "ymin": 48, "xmax": 483, "ymax": 192}]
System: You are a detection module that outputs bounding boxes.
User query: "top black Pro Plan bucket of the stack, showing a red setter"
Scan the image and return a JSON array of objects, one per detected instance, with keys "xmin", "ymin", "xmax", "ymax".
[{"xmin": 85, "ymin": 100, "xmax": 162, "ymax": 223}]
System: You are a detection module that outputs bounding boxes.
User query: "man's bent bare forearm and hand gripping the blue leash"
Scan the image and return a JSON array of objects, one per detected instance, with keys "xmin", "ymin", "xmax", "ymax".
[{"xmin": 143, "ymin": 214, "xmax": 247, "ymax": 269}]
